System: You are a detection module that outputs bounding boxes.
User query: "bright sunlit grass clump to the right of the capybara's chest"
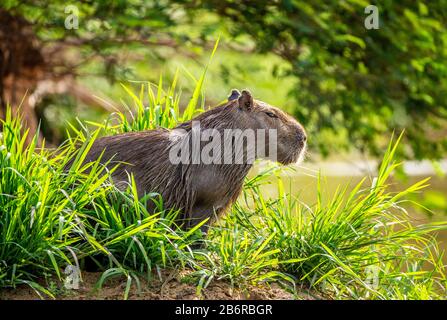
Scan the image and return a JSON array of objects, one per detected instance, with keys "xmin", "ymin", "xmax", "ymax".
[{"xmin": 200, "ymin": 136, "xmax": 447, "ymax": 299}]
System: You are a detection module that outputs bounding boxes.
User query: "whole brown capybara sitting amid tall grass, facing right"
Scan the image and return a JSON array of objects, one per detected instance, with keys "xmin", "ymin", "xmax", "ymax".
[{"xmin": 87, "ymin": 90, "xmax": 306, "ymax": 230}]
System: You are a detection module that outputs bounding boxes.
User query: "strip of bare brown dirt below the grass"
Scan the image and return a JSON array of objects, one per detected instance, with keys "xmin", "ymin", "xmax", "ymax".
[{"xmin": 0, "ymin": 271, "xmax": 316, "ymax": 300}]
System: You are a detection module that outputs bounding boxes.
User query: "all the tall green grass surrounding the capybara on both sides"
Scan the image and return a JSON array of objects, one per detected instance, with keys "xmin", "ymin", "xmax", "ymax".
[{"xmin": 0, "ymin": 59, "xmax": 447, "ymax": 299}]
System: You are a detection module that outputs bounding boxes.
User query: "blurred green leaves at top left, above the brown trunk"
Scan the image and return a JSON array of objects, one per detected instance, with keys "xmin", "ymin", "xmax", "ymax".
[{"xmin": 0, "ymin": 0, "xmax": 175, "ymax": 80}]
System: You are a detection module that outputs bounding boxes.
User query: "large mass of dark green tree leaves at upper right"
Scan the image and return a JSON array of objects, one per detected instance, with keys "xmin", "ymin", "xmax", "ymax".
[{"xmin": 178, "ymin": 0, "xmax": 447, "ymax": 158}]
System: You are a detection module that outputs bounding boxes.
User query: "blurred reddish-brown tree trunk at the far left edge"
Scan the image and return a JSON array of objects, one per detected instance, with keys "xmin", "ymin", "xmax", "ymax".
[{"xmin": 0, "ymin": 10, "xmax": 46, "ymax": 141}]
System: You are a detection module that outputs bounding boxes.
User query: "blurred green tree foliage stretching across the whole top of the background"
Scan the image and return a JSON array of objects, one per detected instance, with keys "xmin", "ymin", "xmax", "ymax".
[{"xmin": 0, "ymin": 0, "xmax": 447, "ymax": 159}]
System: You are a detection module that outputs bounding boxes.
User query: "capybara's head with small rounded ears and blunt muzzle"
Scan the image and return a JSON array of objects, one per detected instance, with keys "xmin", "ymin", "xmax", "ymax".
[{"xmin": 229, "ymin": 90, "xmax": 307, "ymax": 164}]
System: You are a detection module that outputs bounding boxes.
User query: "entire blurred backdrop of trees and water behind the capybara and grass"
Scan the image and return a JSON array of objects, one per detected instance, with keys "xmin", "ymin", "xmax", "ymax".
[{"xmin": 0, "ymin": 0, "xmax": 447, "ymax": 251}]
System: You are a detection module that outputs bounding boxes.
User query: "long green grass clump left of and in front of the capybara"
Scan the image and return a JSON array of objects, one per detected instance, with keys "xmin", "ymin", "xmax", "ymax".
[{"xmin": 0, "ymin": 104, "xmax": 200, "ymax": 296}]
